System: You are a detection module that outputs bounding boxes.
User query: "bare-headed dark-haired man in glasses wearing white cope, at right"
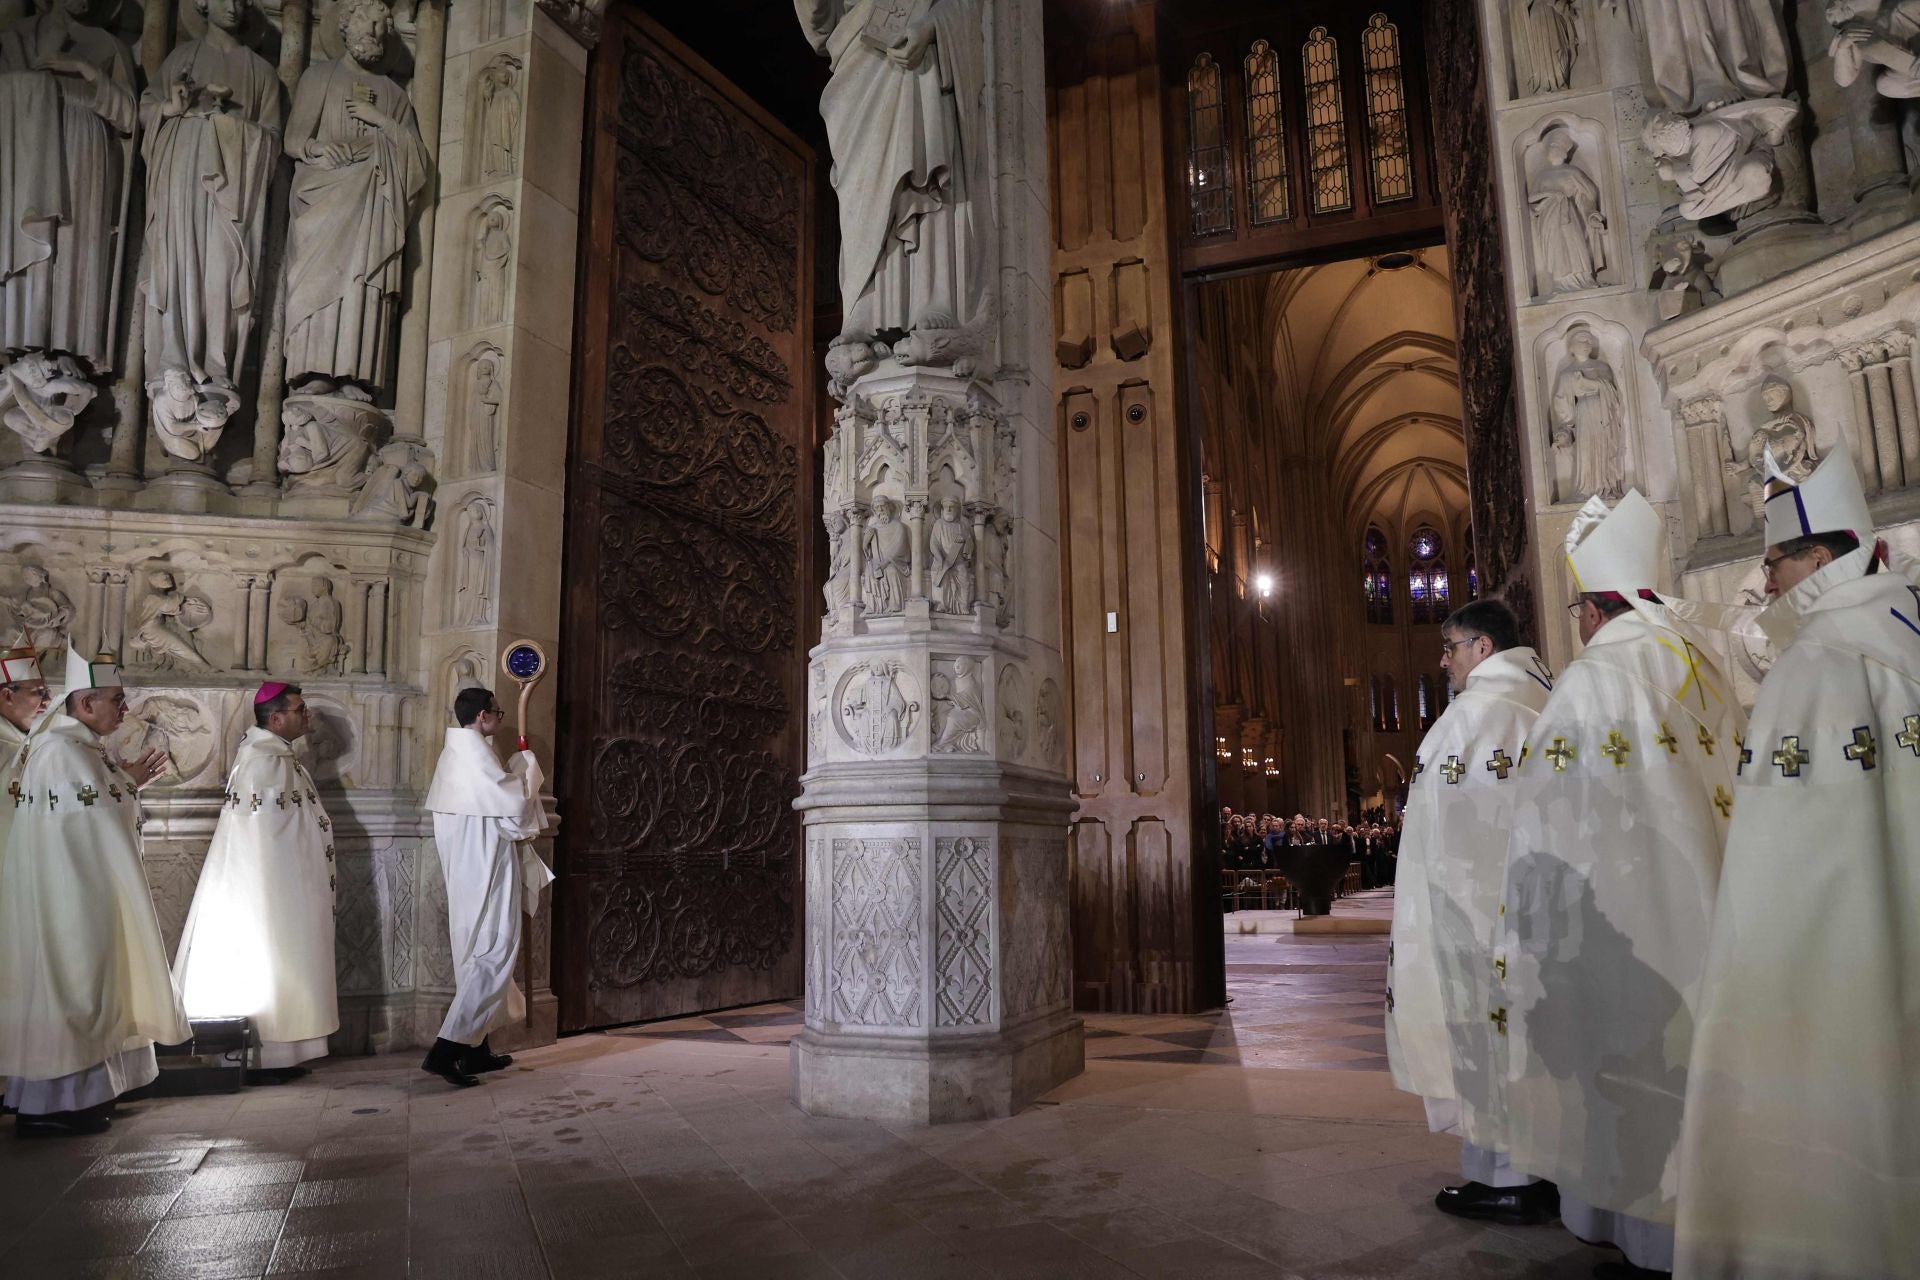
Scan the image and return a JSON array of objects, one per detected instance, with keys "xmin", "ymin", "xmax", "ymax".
[{"xmin": 1386, "ymin": 601, "xmax": 1559, "ymax": 1226}]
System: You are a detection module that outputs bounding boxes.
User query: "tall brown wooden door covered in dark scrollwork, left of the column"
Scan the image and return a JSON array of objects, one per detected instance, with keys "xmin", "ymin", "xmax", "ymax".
[{"xmin": 555, "ymin": 12, "xmax": 818, "ymax": 1031}]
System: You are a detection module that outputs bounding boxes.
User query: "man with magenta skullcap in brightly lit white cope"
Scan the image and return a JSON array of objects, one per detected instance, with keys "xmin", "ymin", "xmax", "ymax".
[{"xmin": 173, "ymin": 681, "xmax": 340, "ymax": 1084}]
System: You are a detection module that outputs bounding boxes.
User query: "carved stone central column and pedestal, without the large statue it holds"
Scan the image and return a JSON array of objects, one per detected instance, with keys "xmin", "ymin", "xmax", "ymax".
[{"xmin": 793, "ymin": 0, "xmax": 1081, "ymax": 1123}]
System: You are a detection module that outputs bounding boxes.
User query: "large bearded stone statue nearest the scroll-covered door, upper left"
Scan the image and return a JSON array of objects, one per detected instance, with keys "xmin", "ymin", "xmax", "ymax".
[{"xmin": 286, "ymin": 0, "xmax": 428, "ymax": 397}]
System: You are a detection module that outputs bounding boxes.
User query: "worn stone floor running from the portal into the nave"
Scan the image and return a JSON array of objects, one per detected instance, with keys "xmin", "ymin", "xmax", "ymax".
[{"xmin": 0, "ymin": 909, "xmax": 1609, "ymax": 1280}]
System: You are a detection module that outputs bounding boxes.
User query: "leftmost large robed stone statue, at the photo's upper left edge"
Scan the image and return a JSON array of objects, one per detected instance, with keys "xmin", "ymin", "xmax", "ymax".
[{"xmin": 0, "ymin": 0, "xmax": 138, "ymax": 429}]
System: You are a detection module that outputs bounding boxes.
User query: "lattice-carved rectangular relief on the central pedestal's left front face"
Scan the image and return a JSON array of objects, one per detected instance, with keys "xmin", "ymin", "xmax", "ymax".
[{"xmin": 824, "ymin": 837, "xmax": 925, "ymax": 1029}]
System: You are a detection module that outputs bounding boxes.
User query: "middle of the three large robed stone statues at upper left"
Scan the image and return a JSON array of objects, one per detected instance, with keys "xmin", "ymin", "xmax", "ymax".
[{"xmin": 140, "ymin": 0, "xmax": 280, "ymax": 462}]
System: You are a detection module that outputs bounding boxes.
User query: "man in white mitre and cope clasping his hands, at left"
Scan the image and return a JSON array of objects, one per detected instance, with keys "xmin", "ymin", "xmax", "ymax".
[{"xmin": 0, "ymin": 651, "xmax": 190, "ymax": 1136}]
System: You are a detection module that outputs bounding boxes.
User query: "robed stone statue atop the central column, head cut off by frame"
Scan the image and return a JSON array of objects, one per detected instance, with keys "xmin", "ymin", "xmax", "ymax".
[{"xmin": 793, "ymin": 0, "xmax": 993, "ymax": 391}]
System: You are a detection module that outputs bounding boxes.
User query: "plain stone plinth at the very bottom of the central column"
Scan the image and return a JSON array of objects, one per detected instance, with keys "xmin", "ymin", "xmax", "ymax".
[{"xmin": 791, "ymin": 1011, "xmax": 1087, "ymax": 1125}]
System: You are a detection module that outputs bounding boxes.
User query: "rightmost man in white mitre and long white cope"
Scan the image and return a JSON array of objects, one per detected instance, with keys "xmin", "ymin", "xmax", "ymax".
[{"xmin": 1676, "ymin": 449, "xmax": 1920, "ymax": 1280}]
